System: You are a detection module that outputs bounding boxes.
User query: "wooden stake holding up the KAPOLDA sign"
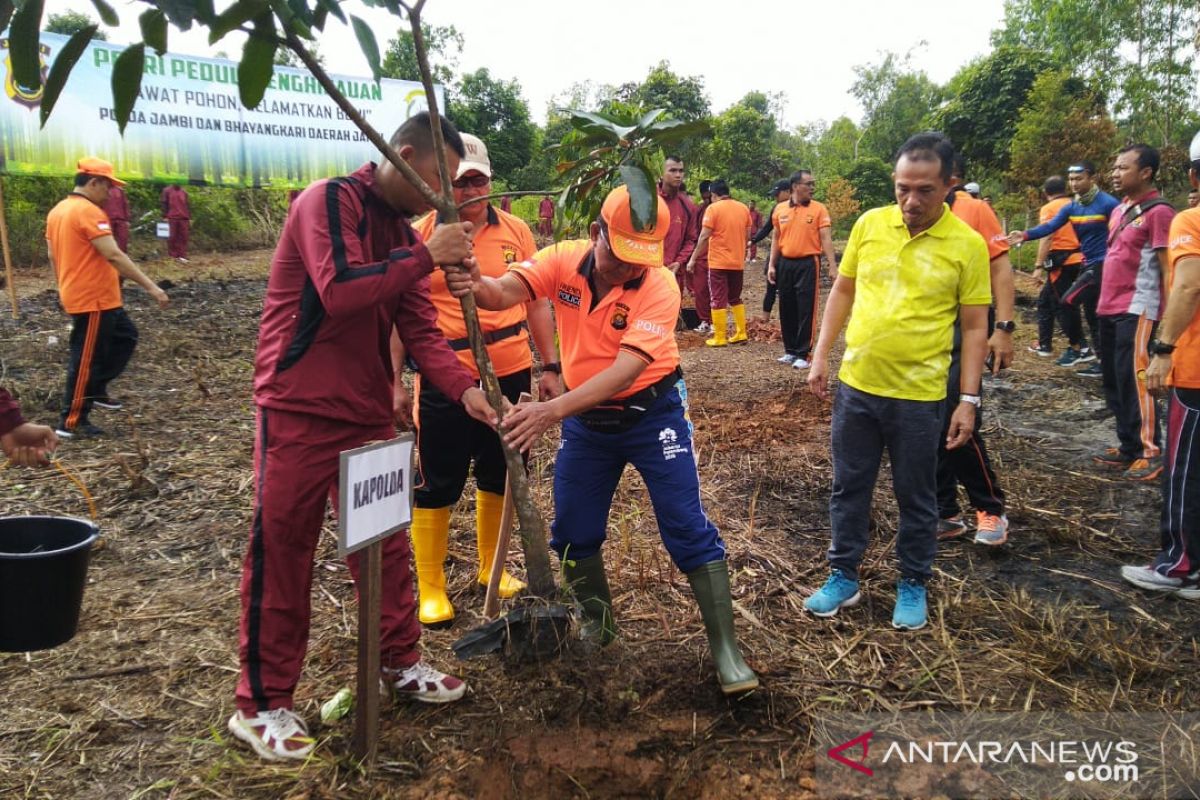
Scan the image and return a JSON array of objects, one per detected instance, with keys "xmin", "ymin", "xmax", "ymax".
[{"xmin": 354, "ymin": 542, "xmax": 379, "ymax": 769}]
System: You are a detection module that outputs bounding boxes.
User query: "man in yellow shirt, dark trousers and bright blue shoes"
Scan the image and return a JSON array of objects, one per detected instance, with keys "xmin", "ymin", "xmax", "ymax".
[{"xmin": 804, "ymin": 133, "xmax": 991, "ymax": 630}]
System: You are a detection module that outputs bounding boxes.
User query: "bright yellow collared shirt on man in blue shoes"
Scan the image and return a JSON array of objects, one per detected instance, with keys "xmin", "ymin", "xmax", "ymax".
[{"xmin": 838, "ymin": 205, "xmax": 991, "ymax": 401}]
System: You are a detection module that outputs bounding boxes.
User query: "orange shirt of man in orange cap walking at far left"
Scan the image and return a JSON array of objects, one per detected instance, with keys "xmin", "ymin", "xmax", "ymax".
[{"xmin": 46, "ymin": 193, "xmax": 121, "ymax": 314}]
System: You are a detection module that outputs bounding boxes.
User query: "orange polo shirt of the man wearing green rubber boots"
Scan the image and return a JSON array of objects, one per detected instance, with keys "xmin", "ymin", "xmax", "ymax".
[{"xmin": 510, "ymin": 239, "xmax": 676, "ymax": 399}]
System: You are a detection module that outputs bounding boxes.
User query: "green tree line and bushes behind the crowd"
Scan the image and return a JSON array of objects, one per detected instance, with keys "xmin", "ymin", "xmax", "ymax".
[{"xmin": 8, "ymin": 0, "xmax": 1200, "ymax": 264}]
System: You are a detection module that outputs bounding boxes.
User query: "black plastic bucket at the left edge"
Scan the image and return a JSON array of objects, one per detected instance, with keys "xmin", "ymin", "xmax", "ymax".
[{"xmin": 0, "ymin": 517, "xmax": 100, "ymax": 652}]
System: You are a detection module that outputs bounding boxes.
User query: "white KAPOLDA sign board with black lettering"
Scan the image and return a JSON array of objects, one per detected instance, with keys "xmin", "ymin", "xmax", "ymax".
[{"xmin": 337, "ymin": 433, "xmax": 415, "ymax": 558}]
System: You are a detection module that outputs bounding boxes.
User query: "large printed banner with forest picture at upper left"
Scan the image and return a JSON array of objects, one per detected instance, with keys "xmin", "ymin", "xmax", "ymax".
[{"xmin": 0, "ymin": 32, "xmax": 444, "ymax": 187}]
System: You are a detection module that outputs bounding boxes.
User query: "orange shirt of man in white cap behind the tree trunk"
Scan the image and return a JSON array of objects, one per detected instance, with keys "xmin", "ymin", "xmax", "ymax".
[{"xmin": 414, "ymin": 206, "xmax": 538, "ymax": 378}]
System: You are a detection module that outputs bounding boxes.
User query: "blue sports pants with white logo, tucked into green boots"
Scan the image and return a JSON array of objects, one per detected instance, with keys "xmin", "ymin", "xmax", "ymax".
[{"xmin": 550, "ymin": 379, "xmax": 725, "ymax": 573}]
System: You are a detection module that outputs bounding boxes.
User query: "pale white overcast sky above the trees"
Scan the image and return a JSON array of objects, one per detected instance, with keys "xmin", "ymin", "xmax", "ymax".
[{"xmin": 46, "ymin": 0, "xmax": 1003, "ymax": 127}]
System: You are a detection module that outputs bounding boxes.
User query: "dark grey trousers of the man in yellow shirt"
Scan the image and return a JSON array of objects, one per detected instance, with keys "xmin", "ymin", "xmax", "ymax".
[{"xmin": 829, "ymin": 384, "xmax": 943, "ymax": 583}]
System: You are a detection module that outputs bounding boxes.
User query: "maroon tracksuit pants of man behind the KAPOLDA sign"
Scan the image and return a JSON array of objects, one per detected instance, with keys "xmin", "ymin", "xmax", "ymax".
[{"xmin": 238, "ymin": 407, "xmax": 421, "ymax": 714}]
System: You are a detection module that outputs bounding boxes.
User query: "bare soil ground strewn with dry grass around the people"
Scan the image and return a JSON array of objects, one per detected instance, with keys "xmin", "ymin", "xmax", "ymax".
[{"xmin": 0, "ymin": 252, "xmax": 1200, "ymax": 799}]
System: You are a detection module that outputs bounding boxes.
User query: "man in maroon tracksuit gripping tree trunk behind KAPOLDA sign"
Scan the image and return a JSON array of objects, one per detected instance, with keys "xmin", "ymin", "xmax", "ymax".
[{"xmin": 229, "ymin": 113, "xmax": 494, "ymax": 760}]
